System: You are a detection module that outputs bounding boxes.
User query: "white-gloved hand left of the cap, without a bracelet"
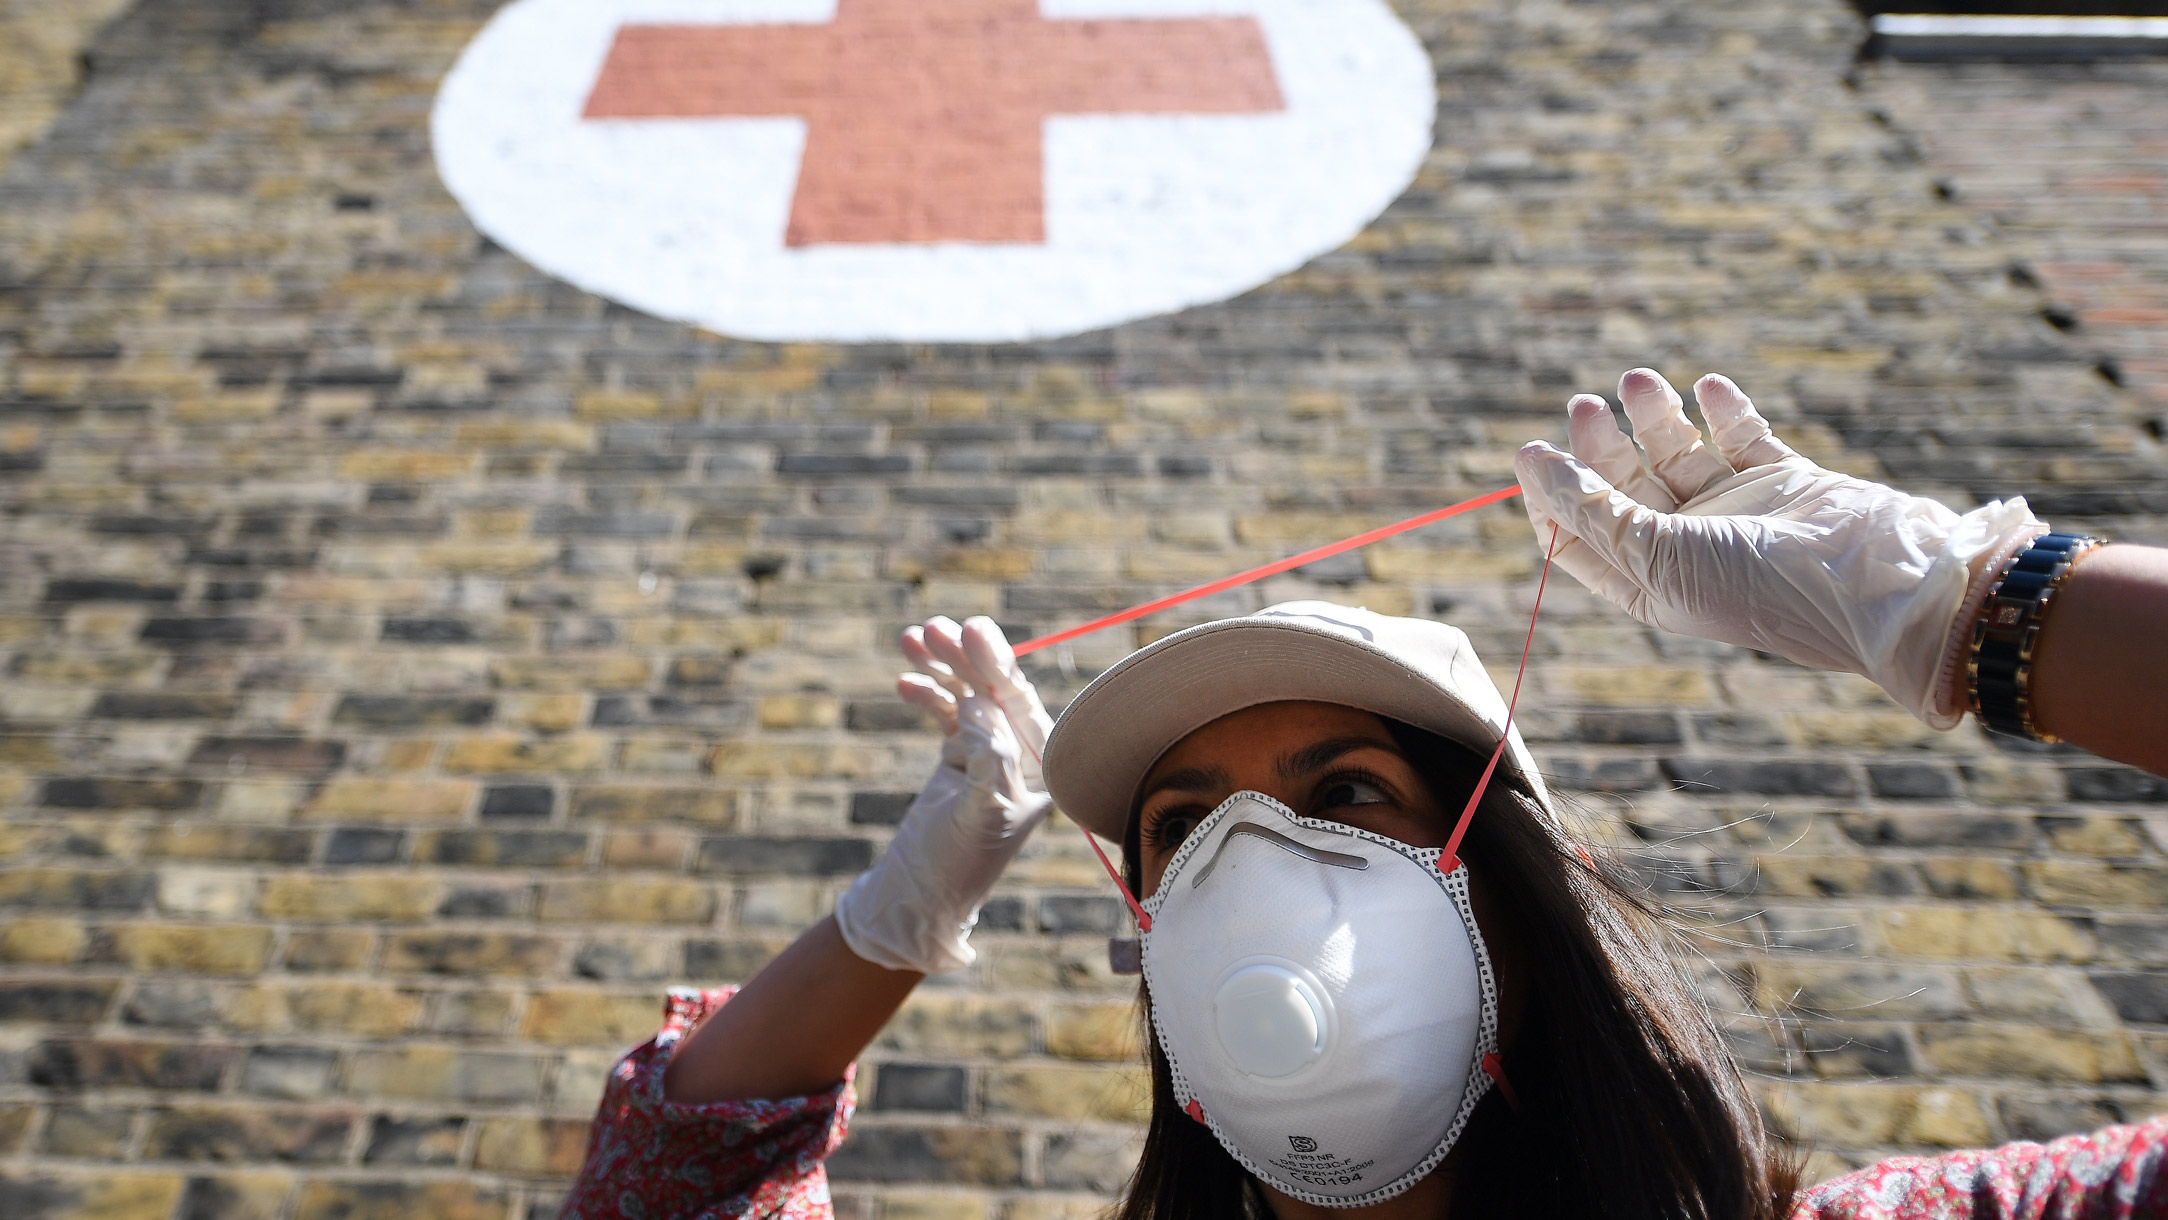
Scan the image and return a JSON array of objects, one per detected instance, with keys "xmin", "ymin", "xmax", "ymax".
[{"xmin": 835, "ymin": 618, "xmax": 1054, "ymax": 975}]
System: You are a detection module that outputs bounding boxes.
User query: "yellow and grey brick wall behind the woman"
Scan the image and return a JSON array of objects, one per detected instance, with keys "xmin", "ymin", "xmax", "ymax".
[{"xmin": 0, "ymin": 0, "xmax": 2168, "ymax": 1220}]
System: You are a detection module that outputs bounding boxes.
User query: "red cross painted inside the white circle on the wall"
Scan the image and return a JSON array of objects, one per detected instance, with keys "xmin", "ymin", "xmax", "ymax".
[{"xmin": 585, "ymin": 0, "xmax": 1283, "ymax": 245}]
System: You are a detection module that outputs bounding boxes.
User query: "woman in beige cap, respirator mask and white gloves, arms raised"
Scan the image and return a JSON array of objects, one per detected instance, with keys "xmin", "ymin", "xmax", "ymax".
[{"xmin": 562, "ymin": 371, "xmax": 2168, "ymax": 1220}]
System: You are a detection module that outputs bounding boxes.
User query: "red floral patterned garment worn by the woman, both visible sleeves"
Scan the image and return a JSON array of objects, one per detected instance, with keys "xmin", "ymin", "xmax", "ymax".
[{"xmin": 557, "ymin": 988, "xmax": 2168, "ymax": 1220}]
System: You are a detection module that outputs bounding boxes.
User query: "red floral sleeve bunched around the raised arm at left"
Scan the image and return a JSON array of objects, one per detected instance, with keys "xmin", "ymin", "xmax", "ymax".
[{"xmin": 557, "ymin": 988, "xmax": 859, "ymax": 1220}]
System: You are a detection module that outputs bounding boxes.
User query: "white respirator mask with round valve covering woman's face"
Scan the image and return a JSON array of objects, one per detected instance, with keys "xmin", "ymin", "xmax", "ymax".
[{"xmin": 1143, "ymin": 791, "xmax": 1502, "ymax": 1207}]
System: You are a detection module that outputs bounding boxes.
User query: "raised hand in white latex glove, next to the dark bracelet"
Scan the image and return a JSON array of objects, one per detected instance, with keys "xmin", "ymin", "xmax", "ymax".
[{"xmin": 1513, "ymin": 368, "xmax": 2047, "ymax": 728}]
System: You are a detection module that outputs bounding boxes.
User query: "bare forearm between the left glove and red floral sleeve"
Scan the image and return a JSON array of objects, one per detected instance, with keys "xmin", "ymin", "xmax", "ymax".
[{"xmin": 663, "ymin": 917, "xmax": 926, "ymax": 1105}]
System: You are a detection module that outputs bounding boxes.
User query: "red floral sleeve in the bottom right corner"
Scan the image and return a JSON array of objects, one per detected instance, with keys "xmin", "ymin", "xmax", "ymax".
[{"xmin": 1793, "ymin": 1114, "xmax": 2168, "ymax": 1220}]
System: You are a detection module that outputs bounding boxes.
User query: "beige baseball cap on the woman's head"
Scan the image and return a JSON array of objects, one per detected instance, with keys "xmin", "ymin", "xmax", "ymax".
[{"xmin": 1045, "ymin": 602, "xmax": 1550, "ymax": 841}]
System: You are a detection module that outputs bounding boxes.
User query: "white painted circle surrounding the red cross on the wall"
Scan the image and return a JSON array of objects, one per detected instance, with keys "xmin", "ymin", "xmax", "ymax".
[{"xmin": 431, "ymin": 0, "xmax": 1435, "ymax": 342}]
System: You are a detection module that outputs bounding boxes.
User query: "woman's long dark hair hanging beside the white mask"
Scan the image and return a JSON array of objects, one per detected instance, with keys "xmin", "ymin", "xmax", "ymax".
[{"xmin": 1117, "ymin": 722, "xmax": 1799, "ymax": 1220}]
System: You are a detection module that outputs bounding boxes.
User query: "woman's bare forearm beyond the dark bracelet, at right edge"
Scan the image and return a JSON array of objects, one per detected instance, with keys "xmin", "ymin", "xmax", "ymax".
[{"xmin": 2031, "ymin": 546, "xmax": 2168, "ymax": 776}]
